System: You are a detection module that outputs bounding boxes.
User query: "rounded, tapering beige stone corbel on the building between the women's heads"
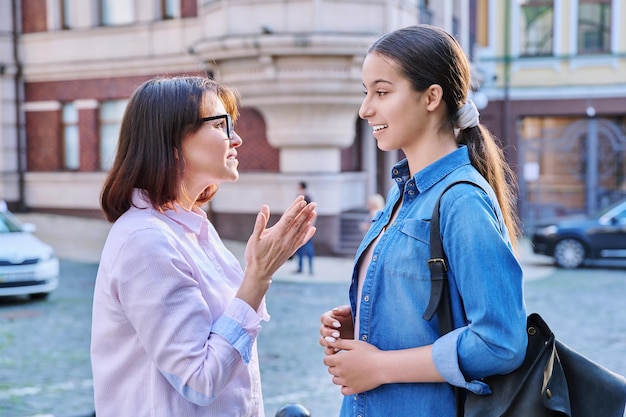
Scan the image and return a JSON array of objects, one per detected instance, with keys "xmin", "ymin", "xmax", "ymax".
[{"xmin": 190, "ymin": 0, "xmax": 418, "ymax": 177}]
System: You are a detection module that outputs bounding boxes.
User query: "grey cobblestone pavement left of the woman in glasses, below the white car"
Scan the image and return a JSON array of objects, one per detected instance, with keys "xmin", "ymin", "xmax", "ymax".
[{"xmin": 0, "ymin": 261, "xmax": 96, "ymax": 417}]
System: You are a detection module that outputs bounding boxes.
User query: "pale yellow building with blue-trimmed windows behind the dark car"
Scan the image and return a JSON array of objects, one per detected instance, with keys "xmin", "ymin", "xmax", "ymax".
[{"xmin": 474, "ymin": 0, "xmax": 626, "ymax": 226}]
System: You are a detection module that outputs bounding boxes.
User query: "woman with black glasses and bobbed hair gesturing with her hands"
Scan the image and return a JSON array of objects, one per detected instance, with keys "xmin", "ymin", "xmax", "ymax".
[{"xmin": 91, "ymin": 77, "xmax": 316, "ymax": 417}]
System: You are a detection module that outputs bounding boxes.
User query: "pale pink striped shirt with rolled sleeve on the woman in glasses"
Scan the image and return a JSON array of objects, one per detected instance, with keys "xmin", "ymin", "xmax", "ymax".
[{"xmin": 91, "ymin": 190, "xmax": 269, "ymax": 417}]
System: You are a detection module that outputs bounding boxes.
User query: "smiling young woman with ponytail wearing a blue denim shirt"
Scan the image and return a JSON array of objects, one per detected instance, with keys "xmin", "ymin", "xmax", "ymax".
[{"xmin": 320, "ymin": 25, "xmax": 527, "ymax": 417}]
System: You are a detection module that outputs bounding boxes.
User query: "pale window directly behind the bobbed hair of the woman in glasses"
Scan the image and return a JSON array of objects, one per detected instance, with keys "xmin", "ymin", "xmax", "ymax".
[{"xmin": 99, "ymin": 100, "xmax": 127, "ymax": 171}]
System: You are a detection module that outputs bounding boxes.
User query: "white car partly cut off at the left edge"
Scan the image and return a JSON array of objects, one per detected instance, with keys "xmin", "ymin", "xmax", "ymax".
[{"xmin": 0, "ymin": 204, "xmax": 59, "ymax": 299}]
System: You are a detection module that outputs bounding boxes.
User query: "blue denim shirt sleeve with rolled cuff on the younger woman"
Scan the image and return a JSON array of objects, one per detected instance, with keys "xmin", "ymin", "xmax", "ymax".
[{"xmin": 433, "ymin": 185, "xmax": 527, "ymax": 394}]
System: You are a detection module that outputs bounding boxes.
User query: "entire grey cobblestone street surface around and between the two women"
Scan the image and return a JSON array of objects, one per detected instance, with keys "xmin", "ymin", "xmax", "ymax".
[{"xmin": 0, "ymin": 216, "xmax": 626, "ymax": 417}]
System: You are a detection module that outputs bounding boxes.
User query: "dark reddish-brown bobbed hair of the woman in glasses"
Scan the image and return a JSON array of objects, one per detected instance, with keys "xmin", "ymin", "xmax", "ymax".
[{"xmin": 100, "ymin": 76, "xmax": 239, "ymax": 222}]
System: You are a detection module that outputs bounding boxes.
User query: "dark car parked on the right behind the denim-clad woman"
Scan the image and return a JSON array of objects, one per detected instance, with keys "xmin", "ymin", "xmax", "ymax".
[{"xmin": 531, "ymin": 199, "xmax": 626, "ymax": 268}]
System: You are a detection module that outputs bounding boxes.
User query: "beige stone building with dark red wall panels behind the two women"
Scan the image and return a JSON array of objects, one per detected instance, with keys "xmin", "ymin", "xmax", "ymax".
[{"xmin": 0, "ymin": 0, "xmax": 470, "ymax": 253}]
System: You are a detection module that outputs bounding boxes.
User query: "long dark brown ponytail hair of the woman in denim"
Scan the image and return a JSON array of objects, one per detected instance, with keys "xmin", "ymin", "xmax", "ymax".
[{"xmin": 368, "ymin": 25, "xmax": 520, "ymax": 244}]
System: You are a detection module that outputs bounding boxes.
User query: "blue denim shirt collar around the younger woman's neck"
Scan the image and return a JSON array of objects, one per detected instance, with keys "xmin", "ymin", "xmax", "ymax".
[{"xmin": 391, "ymin": 145, "xmax": 471, "ymax": 194}]
